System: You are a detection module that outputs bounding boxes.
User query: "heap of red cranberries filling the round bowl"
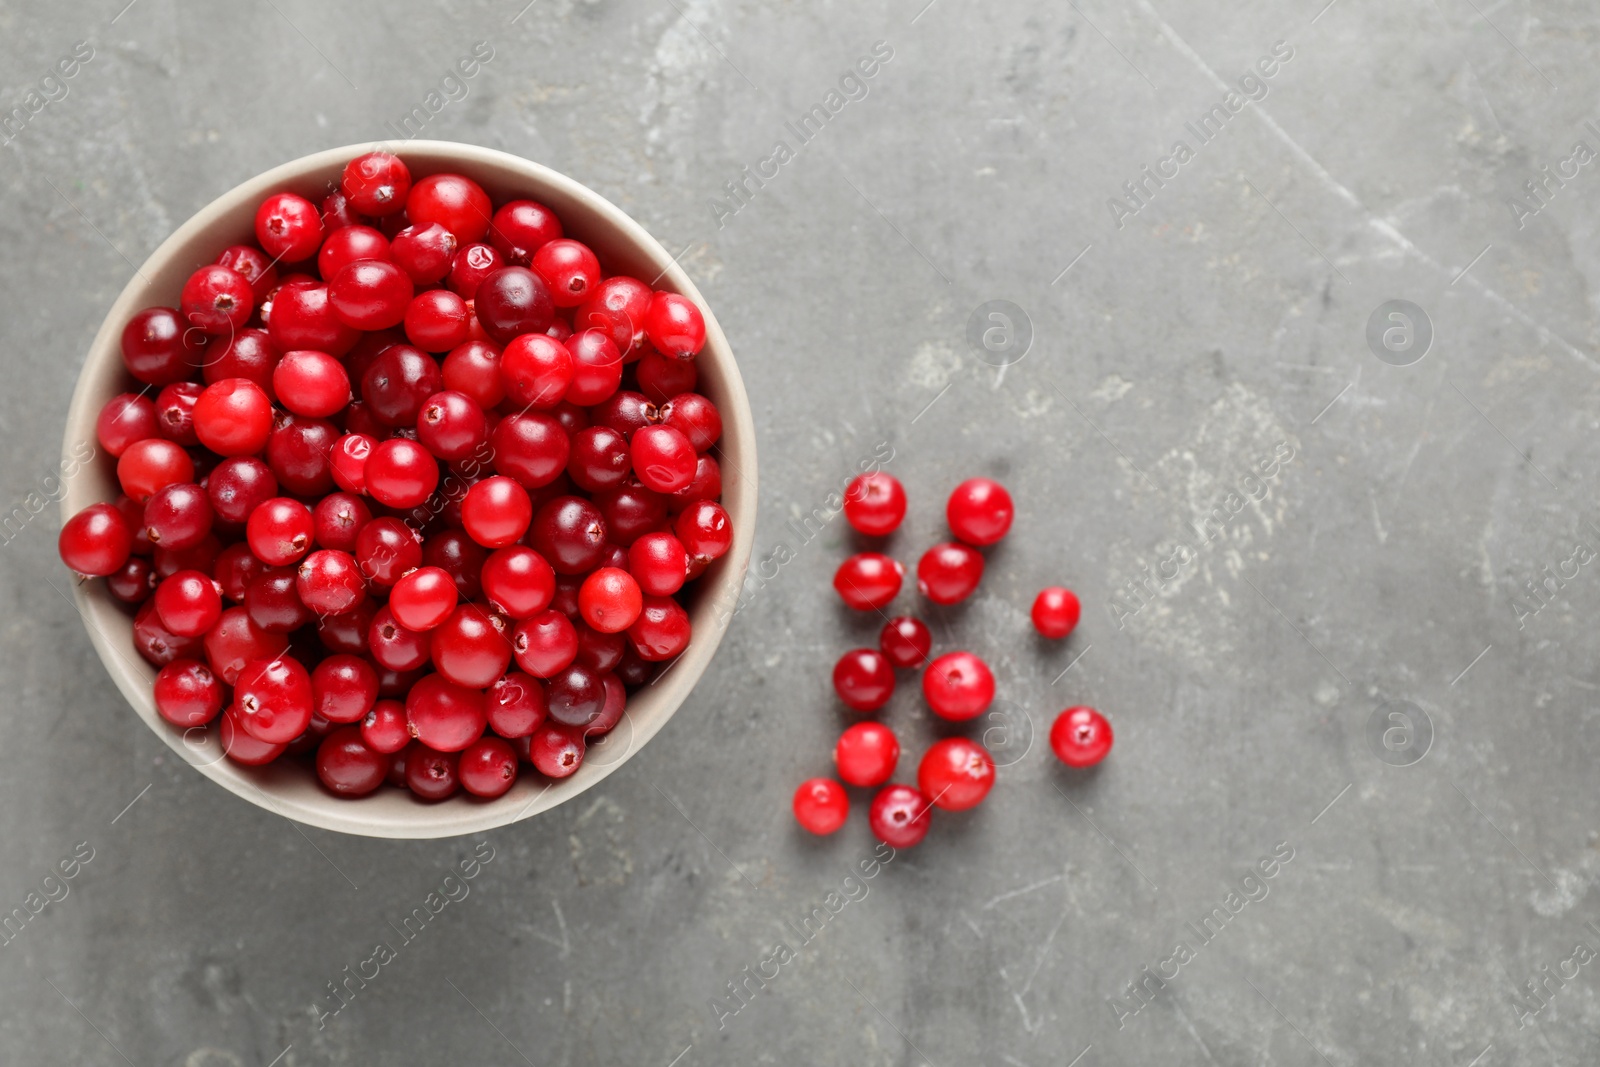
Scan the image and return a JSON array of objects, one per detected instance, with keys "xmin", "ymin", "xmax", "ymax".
[{"xmin": 59, "ymin": 152, "xmax": 733, "ymax": 800}]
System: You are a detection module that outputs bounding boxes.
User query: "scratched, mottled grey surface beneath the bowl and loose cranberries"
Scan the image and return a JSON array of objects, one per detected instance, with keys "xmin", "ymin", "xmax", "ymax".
[{"xmin": 0, "ymin": 0, "xmax": 1600, "ymax": 1067}]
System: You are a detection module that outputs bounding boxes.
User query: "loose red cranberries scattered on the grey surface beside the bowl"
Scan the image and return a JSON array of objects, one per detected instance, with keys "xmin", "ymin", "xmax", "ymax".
[{"xmin": 794, "ymin": 470, "xmax": 1112, "ymax": 848}]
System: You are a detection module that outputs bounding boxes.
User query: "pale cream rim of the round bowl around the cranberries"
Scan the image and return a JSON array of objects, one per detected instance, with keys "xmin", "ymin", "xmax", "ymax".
[{"xmin": 61, "ymin": 141, "xmax": 757, "ymax": 840}]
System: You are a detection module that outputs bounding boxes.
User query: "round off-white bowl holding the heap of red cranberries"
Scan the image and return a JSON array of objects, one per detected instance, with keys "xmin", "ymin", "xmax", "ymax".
[{"xmin": 61, "ymin": 141, "xmax": 755, "ymax": 838}]
